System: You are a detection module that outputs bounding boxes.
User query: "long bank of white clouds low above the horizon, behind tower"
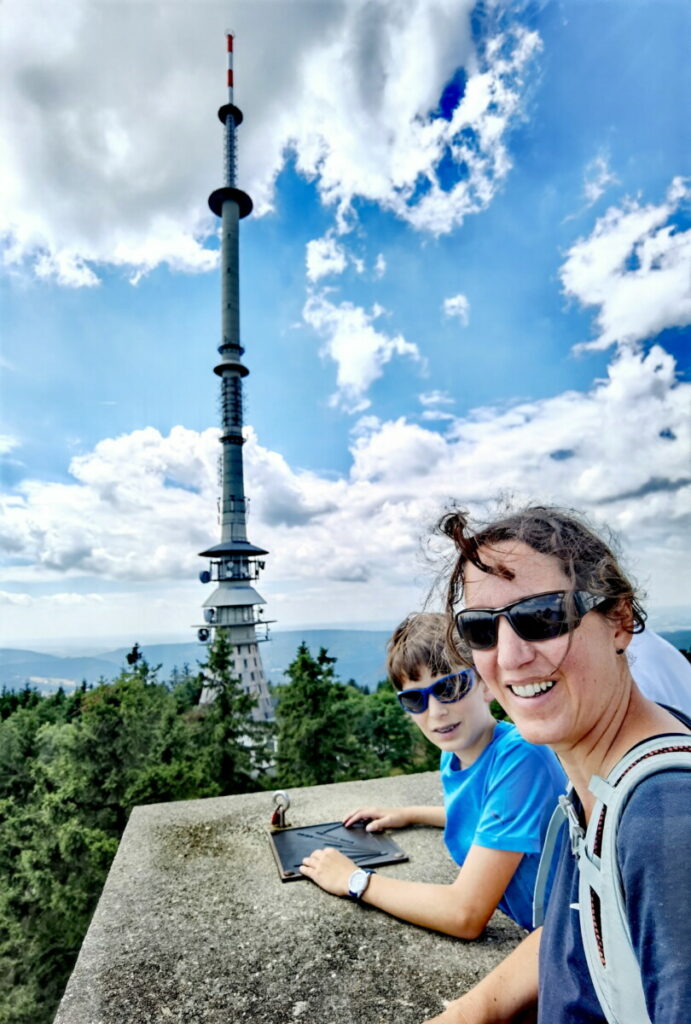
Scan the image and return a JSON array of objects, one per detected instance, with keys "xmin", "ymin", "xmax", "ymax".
[{"xmin": 1, "ymin": 346, "xmax": 691, "ymax": 620}]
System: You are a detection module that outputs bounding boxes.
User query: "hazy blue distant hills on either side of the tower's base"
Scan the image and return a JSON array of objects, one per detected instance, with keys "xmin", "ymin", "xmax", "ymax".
[{"xmin": 0, "ymin": 630, "xmax": 389, "ymax": 693}]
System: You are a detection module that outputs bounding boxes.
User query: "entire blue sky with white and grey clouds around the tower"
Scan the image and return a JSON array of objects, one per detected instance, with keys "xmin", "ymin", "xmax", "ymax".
[{"xmin": 0, "ymin": 0, "xmax": 691, "ymax": 650}]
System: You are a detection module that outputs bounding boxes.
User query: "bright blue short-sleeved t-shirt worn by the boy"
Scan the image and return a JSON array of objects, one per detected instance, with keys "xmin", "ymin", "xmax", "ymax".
[{"xmin": 440, "ymin": 722, "xmax": 566, "ymax": 929}]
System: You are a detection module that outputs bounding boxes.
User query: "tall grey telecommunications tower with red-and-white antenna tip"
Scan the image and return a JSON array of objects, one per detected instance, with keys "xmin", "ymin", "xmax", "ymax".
[{"xmin": 198, "ymin": 33, "xmax": 272, "ymax": 719}]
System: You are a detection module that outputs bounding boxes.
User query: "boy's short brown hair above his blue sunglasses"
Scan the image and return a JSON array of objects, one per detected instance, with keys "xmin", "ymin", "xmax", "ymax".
[{"xmin": 386, "ymin": 611, "xmax": 473, "ymax": 690}]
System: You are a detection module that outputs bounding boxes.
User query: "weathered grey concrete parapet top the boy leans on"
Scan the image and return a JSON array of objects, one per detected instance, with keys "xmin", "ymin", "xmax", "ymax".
[{"xmin": 55, "ymin": 772, "xmax": 522, "ymax": 1024}]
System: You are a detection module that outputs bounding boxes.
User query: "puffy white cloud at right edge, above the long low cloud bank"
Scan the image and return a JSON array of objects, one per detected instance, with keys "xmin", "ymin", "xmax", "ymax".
[{"xmin": 560, "ymin": 178, "xmax": 691, "ymax": 350}]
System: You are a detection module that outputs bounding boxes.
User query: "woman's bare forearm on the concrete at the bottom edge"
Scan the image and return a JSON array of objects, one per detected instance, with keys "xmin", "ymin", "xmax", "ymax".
[{"xmin": 425, "ymin": 928, "xmax": 543, "ymax": 1024}]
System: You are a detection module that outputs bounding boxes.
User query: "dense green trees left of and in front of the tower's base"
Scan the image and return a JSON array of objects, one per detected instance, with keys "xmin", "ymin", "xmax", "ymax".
[{"xmin": 0, "ymin": 637, "xmax": 267, "ymax": 1024}]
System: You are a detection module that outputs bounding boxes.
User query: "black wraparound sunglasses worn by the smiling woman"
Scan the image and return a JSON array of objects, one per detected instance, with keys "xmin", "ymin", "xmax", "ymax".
[{"xmin": 456, "ymin": 590, "xmax": 610, "ymax": 650}]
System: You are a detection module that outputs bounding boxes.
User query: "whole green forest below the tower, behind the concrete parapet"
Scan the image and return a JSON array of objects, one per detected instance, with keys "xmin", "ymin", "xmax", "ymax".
[{"xmin": 0, "ymin": 634, "xmax": 438, "ymax": 1024}]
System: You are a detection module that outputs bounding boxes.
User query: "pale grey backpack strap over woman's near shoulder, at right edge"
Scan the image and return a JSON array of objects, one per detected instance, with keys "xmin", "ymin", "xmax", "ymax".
[{"xmin": 577, "ymin": 735, "xmax": 691, "ymax": 1024}]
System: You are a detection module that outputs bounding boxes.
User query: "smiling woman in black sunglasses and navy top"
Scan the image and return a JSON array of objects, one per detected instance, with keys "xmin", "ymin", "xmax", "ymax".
[{"xmin": 423, "ymin": 507, "xmax": 691, "ymax": 1024}]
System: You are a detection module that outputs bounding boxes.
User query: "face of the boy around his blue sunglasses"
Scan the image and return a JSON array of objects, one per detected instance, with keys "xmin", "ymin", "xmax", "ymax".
[{"xmin": 401, "ymin": 667, "xmax": 493, "ymax": 762}]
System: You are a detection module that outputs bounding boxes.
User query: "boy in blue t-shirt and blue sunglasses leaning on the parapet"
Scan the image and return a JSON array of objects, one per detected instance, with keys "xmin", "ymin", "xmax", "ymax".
[{"xmin": 300, "ymin": 613, "xmax": 566, "ymax": 939}]
